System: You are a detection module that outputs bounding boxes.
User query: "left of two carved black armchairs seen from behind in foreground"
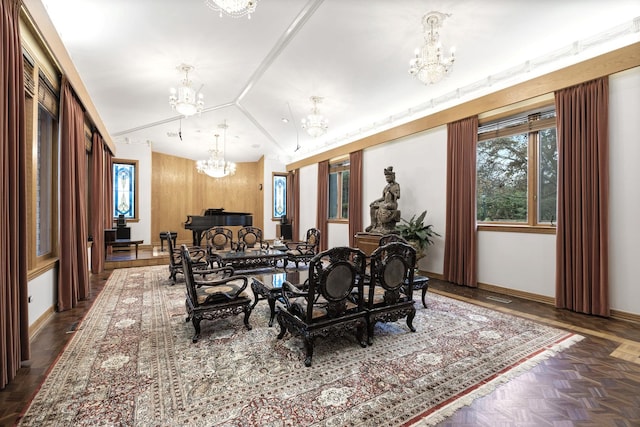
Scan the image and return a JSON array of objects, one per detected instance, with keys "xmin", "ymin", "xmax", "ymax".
[{"xmin": 278, "ymin": 247, "xmax": 367, "ymax": 366}]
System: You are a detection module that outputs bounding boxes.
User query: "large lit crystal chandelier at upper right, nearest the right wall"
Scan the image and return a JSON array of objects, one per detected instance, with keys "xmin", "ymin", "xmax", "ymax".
[{"xmin": 409, "ymin": 12, "xmax": 454, "ymax": 84}]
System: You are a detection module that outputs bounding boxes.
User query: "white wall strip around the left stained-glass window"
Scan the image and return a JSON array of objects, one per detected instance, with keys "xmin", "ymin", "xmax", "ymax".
[{"xmin": 114, "ymin": 143, "xmax": 152, "ymax": 245}]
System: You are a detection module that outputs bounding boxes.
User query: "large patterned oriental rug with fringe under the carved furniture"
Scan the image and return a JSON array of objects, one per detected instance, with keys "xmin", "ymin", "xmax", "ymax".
[{"xmin": 18, "ymin": 266, "xmax": 582, "ymax": 426}]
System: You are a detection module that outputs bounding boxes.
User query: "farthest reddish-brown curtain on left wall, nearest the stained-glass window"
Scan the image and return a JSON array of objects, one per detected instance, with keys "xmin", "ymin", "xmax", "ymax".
[{"xmin": 91, "ymin": 131, "xmax": 113, "ymax": 273}]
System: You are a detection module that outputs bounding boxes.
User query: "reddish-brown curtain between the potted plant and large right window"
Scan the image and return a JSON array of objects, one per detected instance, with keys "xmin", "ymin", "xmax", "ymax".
[{"xmin": 444, "ymin": 116, "xmax": 478, "ymax": 287}]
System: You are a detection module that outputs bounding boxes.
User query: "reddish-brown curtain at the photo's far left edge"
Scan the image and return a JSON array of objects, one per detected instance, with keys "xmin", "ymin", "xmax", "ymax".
[{"xmin": 0, "ymin": 0, "xmax": 31, "ymax": 388}]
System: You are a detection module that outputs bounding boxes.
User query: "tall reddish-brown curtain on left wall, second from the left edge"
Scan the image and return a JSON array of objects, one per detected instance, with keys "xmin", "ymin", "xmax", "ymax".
[{"xmin": 58, "ymin": 78, "xmax": 89, "ymax": 311}]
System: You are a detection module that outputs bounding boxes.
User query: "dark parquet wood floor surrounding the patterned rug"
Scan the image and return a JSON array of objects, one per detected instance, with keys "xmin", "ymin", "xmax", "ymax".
[{"xmin": 0, "ymin": 249, "xmax": 640, "ymax": 427}]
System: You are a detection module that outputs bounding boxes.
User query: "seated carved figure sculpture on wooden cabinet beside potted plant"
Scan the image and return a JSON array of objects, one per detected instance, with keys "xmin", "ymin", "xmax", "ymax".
[{"xmin": 365, "ymin": 166, "xmax": 400, "ymax": 234}]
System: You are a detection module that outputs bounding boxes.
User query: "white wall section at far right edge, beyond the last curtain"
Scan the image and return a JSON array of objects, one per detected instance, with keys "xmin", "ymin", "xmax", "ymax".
[{"xmin": 609, "ymin": 68, "xmax": 640, "ymax": 314}]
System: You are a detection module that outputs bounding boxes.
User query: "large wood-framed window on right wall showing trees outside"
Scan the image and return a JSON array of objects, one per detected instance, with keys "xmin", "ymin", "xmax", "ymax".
[{"xmin": 477, "ymin": 109, "xmax": 558, "ymax": 226}]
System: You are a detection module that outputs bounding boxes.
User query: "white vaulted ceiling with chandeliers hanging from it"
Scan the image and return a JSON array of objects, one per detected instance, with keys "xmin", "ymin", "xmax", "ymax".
[{"xmin": 42, "ymin": 0, "xmax": 640, "ymax": 163}]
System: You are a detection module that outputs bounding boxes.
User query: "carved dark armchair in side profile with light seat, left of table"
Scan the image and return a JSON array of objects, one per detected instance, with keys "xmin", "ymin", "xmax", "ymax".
[{"xmin": 182, "ymin": 245, "xmax": 251, "ymax": 343}]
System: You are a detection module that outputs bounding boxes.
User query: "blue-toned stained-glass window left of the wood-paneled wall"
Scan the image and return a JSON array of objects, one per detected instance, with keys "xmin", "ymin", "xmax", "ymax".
[{"xmin": 113, "ymin": 159, "xmax": 138, "ymax": 220}]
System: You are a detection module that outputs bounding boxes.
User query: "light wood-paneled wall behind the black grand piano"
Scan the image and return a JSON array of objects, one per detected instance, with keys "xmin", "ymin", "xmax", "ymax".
[{"xmin": 151, "ymin": 152, "xmax": 264, "ymax": 245}]
